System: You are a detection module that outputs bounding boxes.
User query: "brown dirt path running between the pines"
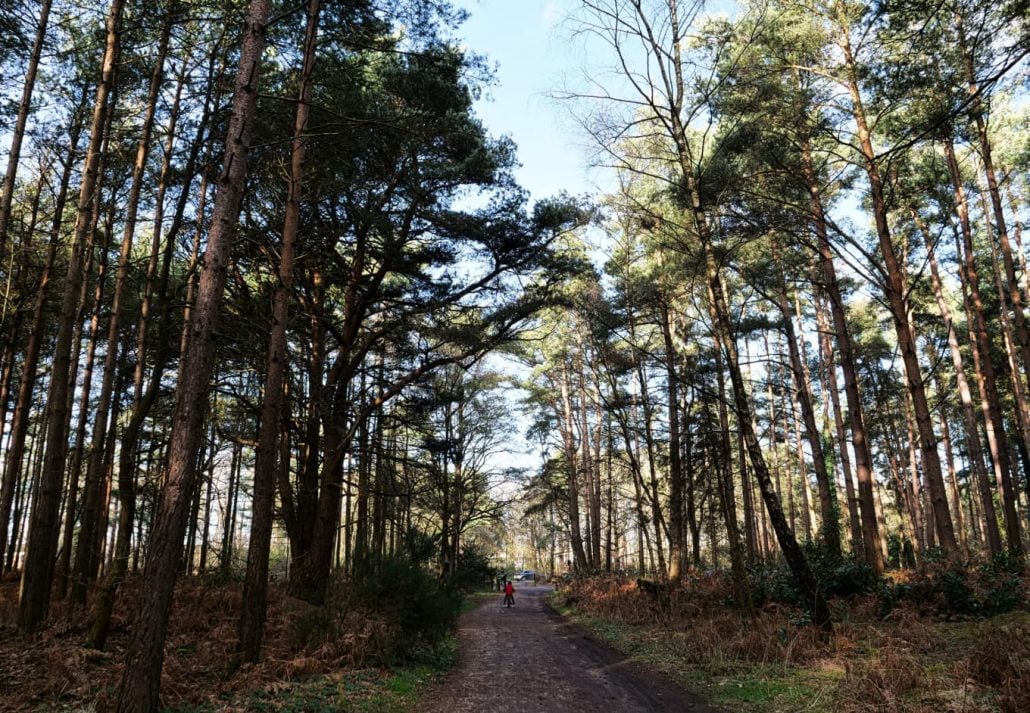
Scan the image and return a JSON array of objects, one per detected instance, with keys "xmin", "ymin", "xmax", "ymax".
[{"xmin": 421, "ymin": 586, "xmax": 715, "ymax": 713}]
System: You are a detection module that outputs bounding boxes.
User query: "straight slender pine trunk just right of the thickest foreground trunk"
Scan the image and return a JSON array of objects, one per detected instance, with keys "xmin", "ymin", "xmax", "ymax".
[{"xmin": 237, "ymin": 0, "xmax": 321, "ymax": 663}]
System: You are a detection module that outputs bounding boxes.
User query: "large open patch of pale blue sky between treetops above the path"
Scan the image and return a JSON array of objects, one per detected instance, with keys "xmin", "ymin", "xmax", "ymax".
[{"xmin": 454, "ymin": 0, "xmax": 594, "ymax": 200}]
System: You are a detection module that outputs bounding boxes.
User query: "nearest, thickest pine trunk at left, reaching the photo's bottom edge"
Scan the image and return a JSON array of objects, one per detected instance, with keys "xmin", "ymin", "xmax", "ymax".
[{"xmin": 117, "ymin": 0, "xmax": 271, "ymax": 713}]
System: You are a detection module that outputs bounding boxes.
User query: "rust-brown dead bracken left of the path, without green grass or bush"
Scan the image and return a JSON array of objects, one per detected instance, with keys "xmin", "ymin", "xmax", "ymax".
[{"xmin": 0, "ymin": 578, "xmax": 401, "ymax": 712}]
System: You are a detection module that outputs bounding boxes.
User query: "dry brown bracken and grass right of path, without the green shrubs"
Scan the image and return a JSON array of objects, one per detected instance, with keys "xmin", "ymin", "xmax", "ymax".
[{"xmin": 562, "ymin": 577, "xmax": 1030, "ymax": 713}]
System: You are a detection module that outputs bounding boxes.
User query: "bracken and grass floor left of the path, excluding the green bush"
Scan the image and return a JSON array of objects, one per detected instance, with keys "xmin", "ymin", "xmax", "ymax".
[{"xmin": 0, "ymin": 575, "xmax": 456, "ymax": 713}]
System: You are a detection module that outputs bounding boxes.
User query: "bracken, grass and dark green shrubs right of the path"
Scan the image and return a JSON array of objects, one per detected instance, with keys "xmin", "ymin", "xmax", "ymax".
[{"xmin": 553, "ymin": 561, "xmax": 1030, "ymax": 713}]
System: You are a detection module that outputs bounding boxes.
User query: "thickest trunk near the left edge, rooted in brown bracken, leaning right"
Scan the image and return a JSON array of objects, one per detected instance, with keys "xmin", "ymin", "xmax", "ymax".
[{"xmin": 19, "ymin": 0, "xmax": 125, "ymax": 632}]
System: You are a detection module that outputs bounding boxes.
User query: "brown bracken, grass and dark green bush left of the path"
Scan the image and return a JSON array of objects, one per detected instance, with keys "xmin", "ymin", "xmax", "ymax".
[{"xmin": 0, "ymin": 559, "xmax": 471, "ymax": 713}]
